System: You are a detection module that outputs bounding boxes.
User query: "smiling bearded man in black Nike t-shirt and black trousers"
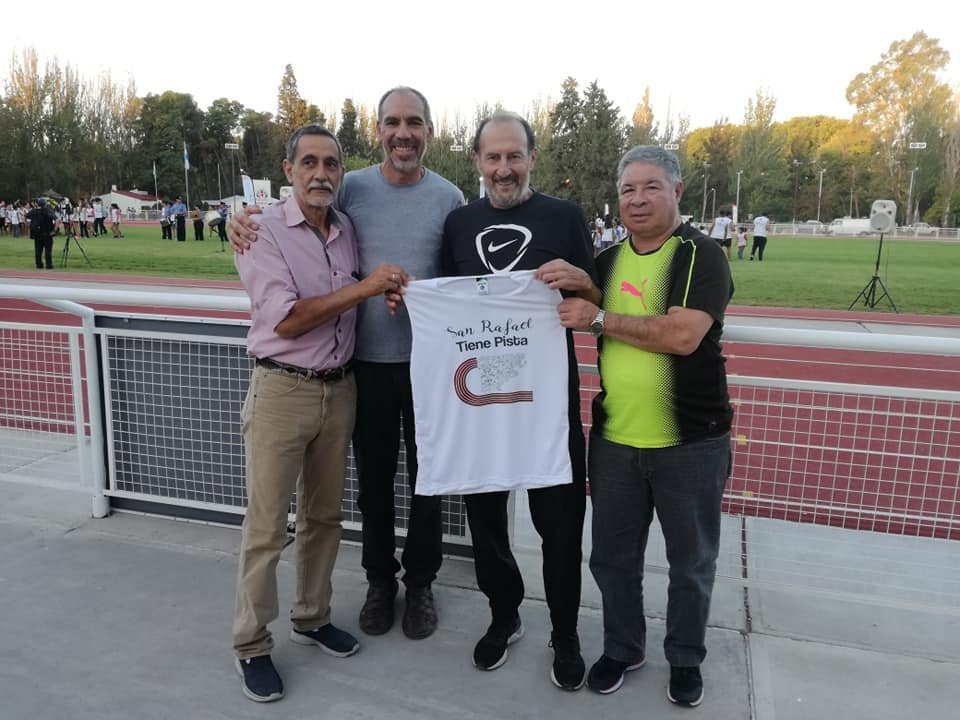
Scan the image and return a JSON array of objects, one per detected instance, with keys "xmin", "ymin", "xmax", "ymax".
[{"xmin": 441, "ymin": 112, "xmax": 600, "ymax": 690}]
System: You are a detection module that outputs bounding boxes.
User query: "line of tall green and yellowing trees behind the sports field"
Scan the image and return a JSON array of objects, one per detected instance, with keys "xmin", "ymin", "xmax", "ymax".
[{"xmin": 0, "ymin": 32, "xmax": 960, "ymax": 226}]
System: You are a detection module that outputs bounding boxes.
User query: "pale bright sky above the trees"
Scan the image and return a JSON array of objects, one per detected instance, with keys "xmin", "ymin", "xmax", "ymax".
[{"xmin": 7, "ymin": 0, "xmax": 960, "ymax": 127}]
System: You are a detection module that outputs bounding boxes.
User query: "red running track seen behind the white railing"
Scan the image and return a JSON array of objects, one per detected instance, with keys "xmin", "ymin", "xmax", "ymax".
[{"xmin": 0, "ymin": 272, "xmax": 960, "ymax": 539}]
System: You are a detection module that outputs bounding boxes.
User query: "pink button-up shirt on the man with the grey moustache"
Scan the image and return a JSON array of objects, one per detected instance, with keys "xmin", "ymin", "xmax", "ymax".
[{"xmin": 234, "ymin": 198, "xmax": 358, "ymax": 370}]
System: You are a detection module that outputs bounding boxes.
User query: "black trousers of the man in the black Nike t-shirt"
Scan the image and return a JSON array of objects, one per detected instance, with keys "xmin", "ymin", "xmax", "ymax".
[{"xmin": 463, "ymin": 414, "xmax": 587, "ymax": 634}]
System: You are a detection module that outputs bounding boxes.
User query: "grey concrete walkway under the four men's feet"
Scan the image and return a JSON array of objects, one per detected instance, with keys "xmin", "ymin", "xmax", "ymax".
[{"xmin": 0, "ymin": 482, "xmax": 960, "ymax": 720}]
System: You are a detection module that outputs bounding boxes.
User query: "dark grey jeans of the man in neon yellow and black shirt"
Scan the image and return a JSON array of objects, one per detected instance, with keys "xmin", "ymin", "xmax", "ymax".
[{"xmin": 589, "ymin": 433, "xmax": 731, "ymax": 667}]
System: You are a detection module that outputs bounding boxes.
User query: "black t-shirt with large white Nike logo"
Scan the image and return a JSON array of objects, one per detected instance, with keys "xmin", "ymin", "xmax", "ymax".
[{"xmin": 441, "ymin": 192, "xmax": 597, "ymax": 430}]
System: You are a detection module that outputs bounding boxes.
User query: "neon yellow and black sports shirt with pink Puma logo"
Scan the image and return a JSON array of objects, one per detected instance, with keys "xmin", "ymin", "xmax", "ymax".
[{"xmin": 593, "ymin": 224, "xmax": 733, "ymax": 448}]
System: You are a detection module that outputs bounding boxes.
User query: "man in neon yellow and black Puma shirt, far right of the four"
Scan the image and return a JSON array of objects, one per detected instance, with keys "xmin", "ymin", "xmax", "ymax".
[{"xmin": 560, "ymin": 145, "xmax": 733, "ymax": 706}]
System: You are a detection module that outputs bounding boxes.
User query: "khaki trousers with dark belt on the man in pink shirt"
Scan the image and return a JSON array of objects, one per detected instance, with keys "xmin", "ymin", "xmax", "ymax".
[{"xmin": 233, "ymin": 366, "xmax": 357, "ymax": 658}]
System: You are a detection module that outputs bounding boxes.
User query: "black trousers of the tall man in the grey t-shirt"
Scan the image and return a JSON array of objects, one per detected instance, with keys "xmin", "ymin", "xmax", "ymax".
[{"xmin": 353, "ymin": 362, "xmax": 443, "ymax": 587}]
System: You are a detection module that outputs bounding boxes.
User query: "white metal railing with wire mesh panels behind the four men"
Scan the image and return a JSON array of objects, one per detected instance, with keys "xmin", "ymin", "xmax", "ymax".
[{"xmin": 0, "ymin": 285, "xmax": 960, "ymax": 614}]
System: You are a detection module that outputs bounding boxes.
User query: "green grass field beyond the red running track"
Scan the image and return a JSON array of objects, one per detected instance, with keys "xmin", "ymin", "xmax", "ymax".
[{"xmin": 0, "ymin": 225, "xmax": 960, "ymax": 315}]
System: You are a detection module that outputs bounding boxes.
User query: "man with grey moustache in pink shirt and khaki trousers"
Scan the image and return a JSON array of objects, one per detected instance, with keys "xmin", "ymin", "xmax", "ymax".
[{"xmin": 233, "ymin": 125, "xmax": 406, "ymax": 702}]
